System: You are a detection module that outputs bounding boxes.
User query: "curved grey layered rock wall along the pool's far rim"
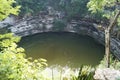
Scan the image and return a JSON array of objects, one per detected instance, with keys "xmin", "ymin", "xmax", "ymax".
[{"xmin": 0, "ymin": 15, "xmax": 120, "ymax": 60}]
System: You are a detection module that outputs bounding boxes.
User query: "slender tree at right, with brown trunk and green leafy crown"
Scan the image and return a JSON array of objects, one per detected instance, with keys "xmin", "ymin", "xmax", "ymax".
[{"xmin": 87, "ymin": 0, "xmax": 120, "ymax": 67}]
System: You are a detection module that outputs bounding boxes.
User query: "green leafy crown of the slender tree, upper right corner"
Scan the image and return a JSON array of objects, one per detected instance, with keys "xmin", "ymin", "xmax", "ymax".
[{"xmin": 87, "ymin": 0, "xmax": 120, "ymax": 19}]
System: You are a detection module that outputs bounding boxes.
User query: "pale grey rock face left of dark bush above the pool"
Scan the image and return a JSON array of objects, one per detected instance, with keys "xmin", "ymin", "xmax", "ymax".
[{"xmin": 10, "ymin": 15, "xmax": 54, "ymax": 36}]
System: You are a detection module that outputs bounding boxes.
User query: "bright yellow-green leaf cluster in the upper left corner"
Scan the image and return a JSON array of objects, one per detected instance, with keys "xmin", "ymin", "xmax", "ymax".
[{"xmin": 0, "ymin": 0, "xmax": 20, "ymax": 20}]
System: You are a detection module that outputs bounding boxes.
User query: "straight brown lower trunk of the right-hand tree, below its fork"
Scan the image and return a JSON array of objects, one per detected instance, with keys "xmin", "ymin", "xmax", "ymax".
[{"xmin": 105, "ymin": 28, "xmax": 110, "ymax": 68}]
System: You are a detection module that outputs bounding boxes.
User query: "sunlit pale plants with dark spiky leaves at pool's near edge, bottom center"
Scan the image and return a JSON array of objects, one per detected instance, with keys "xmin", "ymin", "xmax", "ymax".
[{"xmin": 33, "ymin": 66, "xmax": 95, "ymax": 80}]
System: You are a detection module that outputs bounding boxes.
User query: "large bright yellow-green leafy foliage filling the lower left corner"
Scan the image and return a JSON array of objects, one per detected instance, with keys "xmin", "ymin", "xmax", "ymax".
[{"xmin": 0, "ymin": 33, "xmax": 47, "ymax": 80}]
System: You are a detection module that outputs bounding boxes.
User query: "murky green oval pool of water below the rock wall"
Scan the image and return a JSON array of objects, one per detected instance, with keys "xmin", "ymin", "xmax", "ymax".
[{"xmin": 20, "ymin": 32, "xmax": 104, "ymax": 67}]
